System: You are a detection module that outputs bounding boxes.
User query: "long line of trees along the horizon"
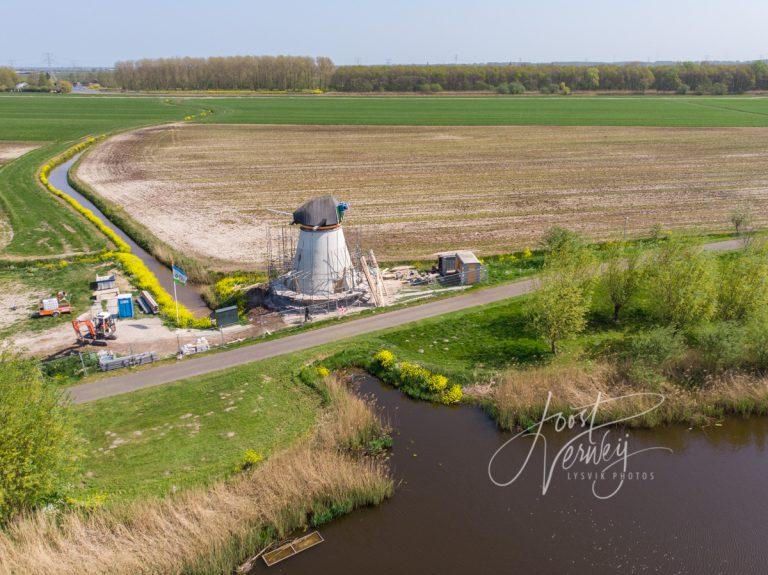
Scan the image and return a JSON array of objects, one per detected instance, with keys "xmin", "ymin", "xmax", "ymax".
[{"xmin": 6, "ymin": 56, "xmax": 768, "ymax": 94}]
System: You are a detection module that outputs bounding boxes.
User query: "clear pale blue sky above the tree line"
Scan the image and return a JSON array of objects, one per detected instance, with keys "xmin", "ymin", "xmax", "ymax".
[{"xmin": 0, "ymin": 0, "xmax": 768, "ymax": 66}]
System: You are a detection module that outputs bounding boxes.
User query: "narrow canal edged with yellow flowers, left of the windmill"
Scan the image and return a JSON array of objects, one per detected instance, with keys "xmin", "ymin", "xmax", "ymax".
[{"xmin": 48, "ymin": 154, "xmax": 210, "ymax": 315}]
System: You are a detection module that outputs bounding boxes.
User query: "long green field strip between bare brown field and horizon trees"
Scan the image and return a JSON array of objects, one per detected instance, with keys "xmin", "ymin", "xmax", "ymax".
[{"xmin": 191, "ymin": 96, "xmax": 768, "ymax": 127}]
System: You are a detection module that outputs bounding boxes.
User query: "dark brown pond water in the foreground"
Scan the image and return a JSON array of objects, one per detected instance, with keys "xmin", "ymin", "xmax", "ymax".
[{"xmin": 258, "ymin": 376, "xmax": 768, "ymax": 575}]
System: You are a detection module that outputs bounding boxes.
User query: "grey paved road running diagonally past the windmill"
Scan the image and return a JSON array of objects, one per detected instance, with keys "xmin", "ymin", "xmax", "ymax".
[{"xmin": 68, "ymin": 240, "xmax": 742, "ymax": 403}]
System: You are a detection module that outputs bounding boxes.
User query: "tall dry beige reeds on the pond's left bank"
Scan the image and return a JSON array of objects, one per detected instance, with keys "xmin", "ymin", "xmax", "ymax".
[{"xmin": 0, "ymin": 379, "xmax": 393, "ymax": 575}]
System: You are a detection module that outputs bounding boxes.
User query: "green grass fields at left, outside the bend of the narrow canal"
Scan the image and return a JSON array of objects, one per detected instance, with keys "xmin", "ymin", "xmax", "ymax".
[{"xmin": 0, "ymin": 94, "xmax": 204, "ymax": 259}]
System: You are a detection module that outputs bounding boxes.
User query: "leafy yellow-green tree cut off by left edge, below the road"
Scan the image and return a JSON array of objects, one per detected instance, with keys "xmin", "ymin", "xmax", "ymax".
[{"xmin": 0, "ymin": 352, "xmax": 78, "ymax": 522}]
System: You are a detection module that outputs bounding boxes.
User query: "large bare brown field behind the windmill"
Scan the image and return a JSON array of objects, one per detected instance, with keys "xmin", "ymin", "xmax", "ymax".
[{"xmin": 79, "ymin": 125, "xmax": 768, "ymax": 268}]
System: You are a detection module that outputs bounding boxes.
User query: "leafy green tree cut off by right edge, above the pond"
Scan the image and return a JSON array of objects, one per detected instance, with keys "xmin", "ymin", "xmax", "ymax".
[{"xmin": 718, "ymin": 241, "xmax": 768, "ymax": 322}]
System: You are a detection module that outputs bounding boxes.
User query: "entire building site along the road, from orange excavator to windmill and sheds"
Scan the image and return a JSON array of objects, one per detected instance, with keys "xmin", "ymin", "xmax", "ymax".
[{"xmin": 6, "ymin": 195, "xmax": 487, "ymax": 371}]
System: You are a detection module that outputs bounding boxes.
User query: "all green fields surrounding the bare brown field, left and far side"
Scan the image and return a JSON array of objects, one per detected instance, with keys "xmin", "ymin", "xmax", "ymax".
[{"xmin": 0, "ymin": 94, "xmax": 768, "ymax": 259}]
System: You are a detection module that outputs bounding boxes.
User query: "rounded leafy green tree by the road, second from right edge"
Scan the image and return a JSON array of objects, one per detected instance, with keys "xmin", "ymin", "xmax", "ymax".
[{"xmin": 646, "ymin": 238, "xmax": 717, "ymax": 328}]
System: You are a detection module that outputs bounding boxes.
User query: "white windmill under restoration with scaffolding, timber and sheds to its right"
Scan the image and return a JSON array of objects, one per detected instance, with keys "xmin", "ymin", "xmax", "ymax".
[{"xmin": 261, "ymin": 195, "xmax": 486, "ymax": 325}]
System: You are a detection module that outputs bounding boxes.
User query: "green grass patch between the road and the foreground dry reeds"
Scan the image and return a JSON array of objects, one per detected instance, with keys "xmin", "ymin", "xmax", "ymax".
[{"xmin": 77, "ymin": 356, "xmax": 320, "ymax": 502}]
